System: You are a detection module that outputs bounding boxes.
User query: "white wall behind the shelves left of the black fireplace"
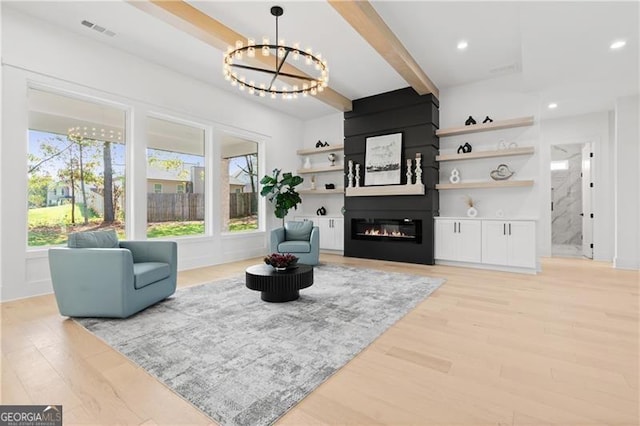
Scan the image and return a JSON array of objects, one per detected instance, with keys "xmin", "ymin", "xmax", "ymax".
[{"xmin": 296, "ymin": 112, "xmax": 344, "ymax": 217}]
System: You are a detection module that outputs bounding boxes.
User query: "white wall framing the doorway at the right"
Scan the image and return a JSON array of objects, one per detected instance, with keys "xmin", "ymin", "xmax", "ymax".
[{"xmin": 538, "ymin": 111, "xmax": 614, "ymax": 262}]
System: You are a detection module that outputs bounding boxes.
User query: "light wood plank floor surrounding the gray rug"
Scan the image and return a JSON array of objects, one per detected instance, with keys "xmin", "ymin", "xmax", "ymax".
[{"xmin": 0, "ymin": 255, "xmax": 640, "ymax": 425}]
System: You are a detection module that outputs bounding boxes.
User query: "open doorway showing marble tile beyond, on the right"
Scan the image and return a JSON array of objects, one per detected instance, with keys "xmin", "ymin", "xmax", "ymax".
[{"xmin": 551, "ymin": 143, "xmax": 593, "ymax": 259}]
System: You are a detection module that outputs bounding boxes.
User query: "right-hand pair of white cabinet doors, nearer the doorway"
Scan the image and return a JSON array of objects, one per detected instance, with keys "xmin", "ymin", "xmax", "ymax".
[{"xmin": 482, "ymin": 220, "xmax": 536, "ymax": 268}]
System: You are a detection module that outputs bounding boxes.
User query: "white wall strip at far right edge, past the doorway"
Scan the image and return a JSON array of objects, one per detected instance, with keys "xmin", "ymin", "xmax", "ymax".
[{"xmin": 614, "ymin": 95, "xmax": 640, "ymax": 269}]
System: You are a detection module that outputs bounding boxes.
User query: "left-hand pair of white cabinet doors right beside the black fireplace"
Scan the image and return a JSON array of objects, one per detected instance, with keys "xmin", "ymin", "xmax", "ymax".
[{"xmin": 435, "ymin": 219, "xmax": 482, "ymax": 263}]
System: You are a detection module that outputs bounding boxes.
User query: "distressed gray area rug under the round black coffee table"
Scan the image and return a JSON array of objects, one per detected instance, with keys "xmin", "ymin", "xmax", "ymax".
[{"xmin": 76, "ymin": 265, "xmax": 444, "ymax": 425}]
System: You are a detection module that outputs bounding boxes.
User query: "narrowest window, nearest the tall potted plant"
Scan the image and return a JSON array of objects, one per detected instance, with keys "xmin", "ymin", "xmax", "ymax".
[{"xmin": 221, "ymin": 135, "xmax": 259, "ymax": 232}]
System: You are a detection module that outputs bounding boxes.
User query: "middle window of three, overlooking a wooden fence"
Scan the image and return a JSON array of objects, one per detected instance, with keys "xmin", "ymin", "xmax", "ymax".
[{"xmin": 147, "ymin": 117, "xmax": 206, "ymax": 238}]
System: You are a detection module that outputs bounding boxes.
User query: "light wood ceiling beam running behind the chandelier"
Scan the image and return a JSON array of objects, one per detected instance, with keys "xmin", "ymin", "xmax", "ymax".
[{"xmin": 128, "ymin": 0, "xmax": 353, "ymax": 111}]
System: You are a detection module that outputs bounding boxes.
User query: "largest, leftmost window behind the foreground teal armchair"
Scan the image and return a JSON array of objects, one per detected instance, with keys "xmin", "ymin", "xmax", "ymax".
[{"xmin": 27, "ymin": 89, "xmax": 125, "ymax": 247}]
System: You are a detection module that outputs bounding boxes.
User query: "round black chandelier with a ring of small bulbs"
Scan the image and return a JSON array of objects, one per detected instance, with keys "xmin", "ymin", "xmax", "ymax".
[{"xmin": 223, "ymin": 6, "xmax": 329, "ymax": 99}]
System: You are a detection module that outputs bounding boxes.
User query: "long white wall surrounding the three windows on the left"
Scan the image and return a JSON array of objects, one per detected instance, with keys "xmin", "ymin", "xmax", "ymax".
[{"xmin": 0, "ymin": 8, "xmax": 303, "ymax": 300}]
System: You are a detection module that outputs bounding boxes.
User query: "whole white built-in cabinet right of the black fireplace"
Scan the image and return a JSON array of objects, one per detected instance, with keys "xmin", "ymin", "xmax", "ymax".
[{"xmin": 435, "ymin": 217, "xmax": 536, "ymax": 272}]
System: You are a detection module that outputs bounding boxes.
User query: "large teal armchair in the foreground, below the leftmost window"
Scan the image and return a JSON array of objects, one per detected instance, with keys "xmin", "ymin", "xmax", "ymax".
[{"xmin": 49, "ymin": 231, "xmax": 178, "ymax": 318}]
